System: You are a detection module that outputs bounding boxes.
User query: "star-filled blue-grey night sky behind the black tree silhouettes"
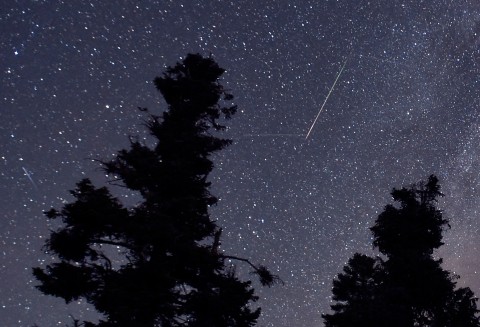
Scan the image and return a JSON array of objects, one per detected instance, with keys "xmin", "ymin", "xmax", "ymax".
[{"xmin": 0, "ymin": 0, "xmax": 480, "ymax": 327}]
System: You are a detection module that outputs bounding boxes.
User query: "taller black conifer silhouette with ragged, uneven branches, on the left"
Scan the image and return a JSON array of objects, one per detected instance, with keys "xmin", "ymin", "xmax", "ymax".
[{"xmin": 33, "ymin": 54, "xmax": 279, "ymax": 327}]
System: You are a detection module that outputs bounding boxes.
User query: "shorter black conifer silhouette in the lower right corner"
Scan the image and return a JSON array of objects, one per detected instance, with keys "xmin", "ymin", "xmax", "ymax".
[{"xmin": 323, "ymin": 175, "xmax": 480, "ymax": 327}]
